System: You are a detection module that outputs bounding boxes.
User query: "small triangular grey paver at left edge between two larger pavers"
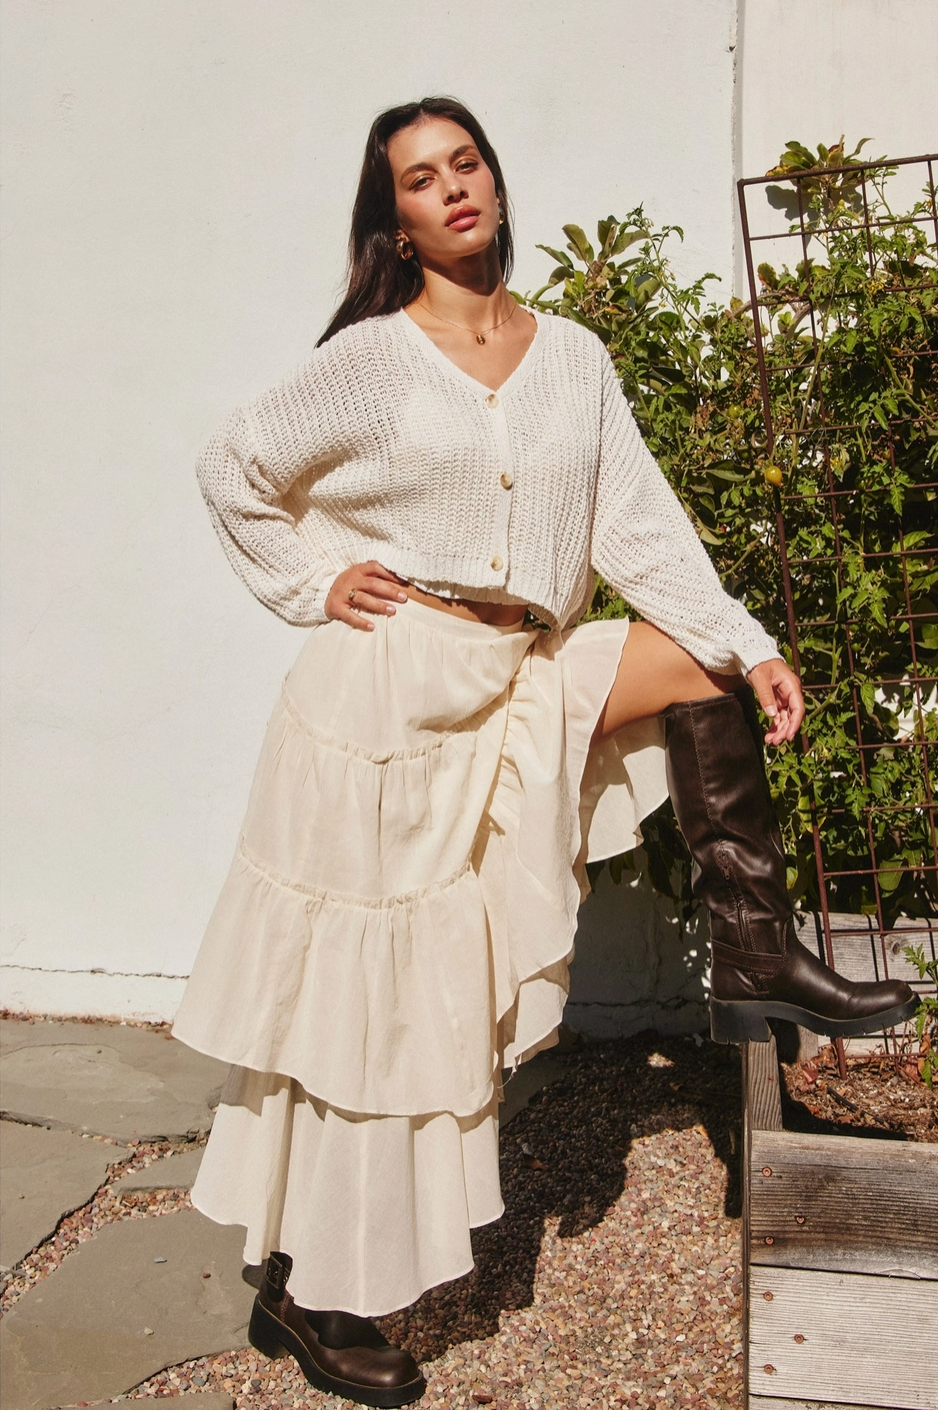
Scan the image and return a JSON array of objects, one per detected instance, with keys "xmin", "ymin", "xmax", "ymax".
[{"xmin": 0, "ymin": 1121, "xmax": 130, "ymax": 1269}]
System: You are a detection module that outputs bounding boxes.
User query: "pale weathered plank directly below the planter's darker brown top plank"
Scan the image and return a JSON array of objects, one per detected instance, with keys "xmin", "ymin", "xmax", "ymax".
[{"xmin": 749, "ymin": 1268, "xmax": 938, "ymax": 1410}]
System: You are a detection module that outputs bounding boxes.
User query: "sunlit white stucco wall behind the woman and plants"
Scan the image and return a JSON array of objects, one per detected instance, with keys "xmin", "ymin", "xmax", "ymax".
[{"xmin": 0, "ymin": 0, "xmax": 935, "ymax": 1026}]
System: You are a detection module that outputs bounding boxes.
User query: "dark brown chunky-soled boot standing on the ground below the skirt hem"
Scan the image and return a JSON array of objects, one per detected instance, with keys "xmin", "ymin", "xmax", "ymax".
[{"xmin": 248, "ymin": 1253, "xmax": 426, "ymax": 1406}]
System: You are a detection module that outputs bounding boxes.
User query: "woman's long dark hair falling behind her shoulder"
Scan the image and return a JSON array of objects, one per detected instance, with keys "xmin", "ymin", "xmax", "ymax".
[{"xmin": 317, "ymin": 97, "xmax": 515, "ymax": 347}]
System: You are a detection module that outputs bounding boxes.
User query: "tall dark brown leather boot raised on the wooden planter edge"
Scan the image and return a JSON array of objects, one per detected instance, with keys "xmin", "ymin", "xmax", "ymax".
[{"xmin": 664, "ymin": 687, "xmax": 918, "ymax": 1043}]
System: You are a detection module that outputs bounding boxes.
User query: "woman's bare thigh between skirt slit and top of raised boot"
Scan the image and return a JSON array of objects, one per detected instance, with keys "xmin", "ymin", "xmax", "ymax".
[{"xmin": 594, "ymin": 622, "xmax": 742, "ymax": 740}]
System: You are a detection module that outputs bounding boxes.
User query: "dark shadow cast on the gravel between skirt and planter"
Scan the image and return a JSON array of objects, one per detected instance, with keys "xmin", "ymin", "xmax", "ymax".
[{"xmin": 381, "ymin": 1034, "xmax": 742, "ymax": 1361}]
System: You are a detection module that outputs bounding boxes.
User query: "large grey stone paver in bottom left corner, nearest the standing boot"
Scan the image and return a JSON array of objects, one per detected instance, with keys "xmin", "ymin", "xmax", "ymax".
[{"xmin": 0, "ymin": 1210, "xmax": 254, "ymax": 1410}]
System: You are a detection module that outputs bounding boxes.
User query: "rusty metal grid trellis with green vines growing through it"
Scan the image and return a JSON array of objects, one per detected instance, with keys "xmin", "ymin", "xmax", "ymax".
[{"xmin": 738, "ymin": 155, "xmax": 938, "ymax": 1059}]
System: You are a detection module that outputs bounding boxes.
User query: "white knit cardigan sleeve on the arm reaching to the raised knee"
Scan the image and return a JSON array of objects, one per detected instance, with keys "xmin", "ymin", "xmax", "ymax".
[{"xmin": 591, "ymin": 341, "xmax": 779, "ymax": 673}]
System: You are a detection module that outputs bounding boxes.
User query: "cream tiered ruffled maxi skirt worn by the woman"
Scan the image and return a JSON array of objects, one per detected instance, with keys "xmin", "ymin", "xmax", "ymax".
[{"xmin": 173, "ymin": 602, "xmax": 667, "ymax": 1316}]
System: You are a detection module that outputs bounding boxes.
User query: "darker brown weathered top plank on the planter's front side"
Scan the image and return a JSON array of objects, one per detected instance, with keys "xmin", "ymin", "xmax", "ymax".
[{"xmin": 749, "ymin": 1131, "xmax": 938, "ymax": 1277}]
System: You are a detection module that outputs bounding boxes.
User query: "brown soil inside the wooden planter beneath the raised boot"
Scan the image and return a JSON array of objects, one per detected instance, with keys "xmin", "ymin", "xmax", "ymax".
[{"xmin": 781, "ymin": 1045, "xmax": 938, "ymax": 1142}]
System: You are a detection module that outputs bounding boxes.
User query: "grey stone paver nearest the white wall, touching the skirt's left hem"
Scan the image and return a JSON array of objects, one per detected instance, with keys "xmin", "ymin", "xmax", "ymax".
[{"xmin": 0, "ymin": 1019, "xmax": 227, "ymax": 1141}]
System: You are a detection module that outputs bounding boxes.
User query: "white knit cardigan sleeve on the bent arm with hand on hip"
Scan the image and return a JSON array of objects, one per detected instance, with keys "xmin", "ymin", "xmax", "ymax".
[{"xmin": 196, "ymin": 364, "xmax": 343, "ymax": 626}]
